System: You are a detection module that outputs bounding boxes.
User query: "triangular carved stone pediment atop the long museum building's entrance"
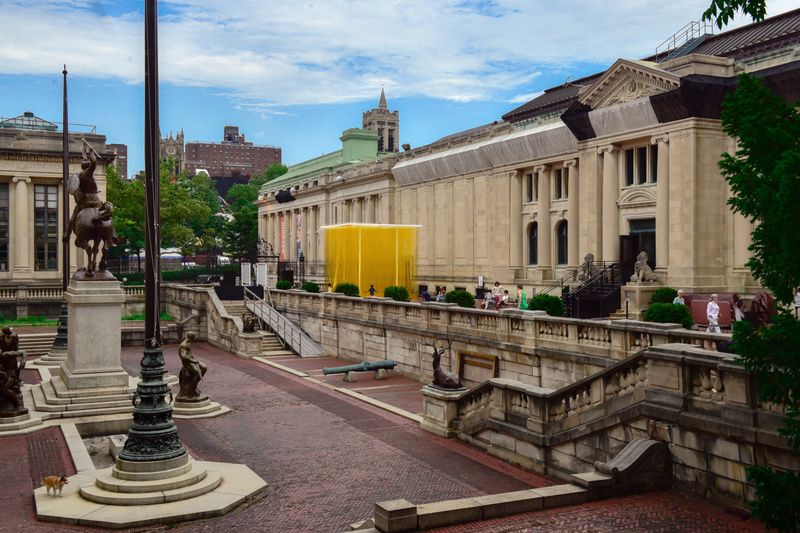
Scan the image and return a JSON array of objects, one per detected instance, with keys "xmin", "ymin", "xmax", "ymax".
[{"xmin": 578, "ymin": 59, "xmax": 680, "ymax": 109}]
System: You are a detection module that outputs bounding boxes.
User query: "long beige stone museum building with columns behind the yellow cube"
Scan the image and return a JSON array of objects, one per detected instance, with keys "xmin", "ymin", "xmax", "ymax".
[{"xmin": 259, "ymin": 10, "xmax": 800, "ymax": 293}]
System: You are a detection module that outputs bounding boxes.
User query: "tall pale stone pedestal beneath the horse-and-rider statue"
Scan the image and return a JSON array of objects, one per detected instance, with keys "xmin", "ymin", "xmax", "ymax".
[{"xmin": 60, "ymin": 279, "xmax": 129, "ymax": 390}]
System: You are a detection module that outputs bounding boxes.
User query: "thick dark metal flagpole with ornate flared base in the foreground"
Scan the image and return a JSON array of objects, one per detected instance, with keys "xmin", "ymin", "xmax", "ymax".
[{"xmin": 119, "ymin": 0, "xmax": 186, "ymax": 461}]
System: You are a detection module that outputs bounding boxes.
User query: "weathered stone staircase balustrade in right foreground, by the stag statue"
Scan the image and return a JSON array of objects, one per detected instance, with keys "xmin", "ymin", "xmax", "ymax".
[{"xmin": 421, "ymin": 344, "xmax": 800, "ymax": 509}]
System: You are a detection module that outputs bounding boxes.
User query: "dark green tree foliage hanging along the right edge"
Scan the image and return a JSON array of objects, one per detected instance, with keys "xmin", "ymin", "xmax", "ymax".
[{"xmin": 712, "ymin": 67, "xmax": 800, "ymax": 531}]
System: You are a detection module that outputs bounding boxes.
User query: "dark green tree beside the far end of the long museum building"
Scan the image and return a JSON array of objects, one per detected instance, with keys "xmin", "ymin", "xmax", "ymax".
[{"xmin": 221, "ymin": 165, "xmax": 288, "ymax": 263}]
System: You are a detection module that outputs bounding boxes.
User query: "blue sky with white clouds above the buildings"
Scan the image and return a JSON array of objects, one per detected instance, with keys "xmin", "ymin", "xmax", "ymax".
[{"xmin": 0, "ymin": 0, "xmax": 798, "ymax": 174}]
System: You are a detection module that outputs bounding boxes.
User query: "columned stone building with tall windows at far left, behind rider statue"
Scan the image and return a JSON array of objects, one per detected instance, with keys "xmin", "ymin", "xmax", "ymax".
[{"xmin": 0, "ymin": 111, "xmax": 114, "ymax": 316}]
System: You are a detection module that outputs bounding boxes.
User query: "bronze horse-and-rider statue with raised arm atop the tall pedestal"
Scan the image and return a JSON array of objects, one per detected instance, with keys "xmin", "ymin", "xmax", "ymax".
[{"xmin": 62, "ymin": 139, "xmax": 120, "ymax": 279}]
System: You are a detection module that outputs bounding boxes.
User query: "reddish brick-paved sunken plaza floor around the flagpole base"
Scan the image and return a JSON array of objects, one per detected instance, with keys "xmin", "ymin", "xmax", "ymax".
[{"xmin": 0, "ymin": 344, "xmax": 763, "ymax": 532}]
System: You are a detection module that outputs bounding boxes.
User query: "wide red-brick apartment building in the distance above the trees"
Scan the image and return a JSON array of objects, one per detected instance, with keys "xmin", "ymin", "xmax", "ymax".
[{"xmin": 185, "ymin": 126, "xmax": 281, "ymax": 179}]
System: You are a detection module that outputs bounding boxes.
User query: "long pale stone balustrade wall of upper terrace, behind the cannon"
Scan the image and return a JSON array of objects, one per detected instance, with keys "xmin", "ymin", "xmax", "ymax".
[{"xmin": 270, "ymin": 290, "xmax": 730, "ymax": 388}]
